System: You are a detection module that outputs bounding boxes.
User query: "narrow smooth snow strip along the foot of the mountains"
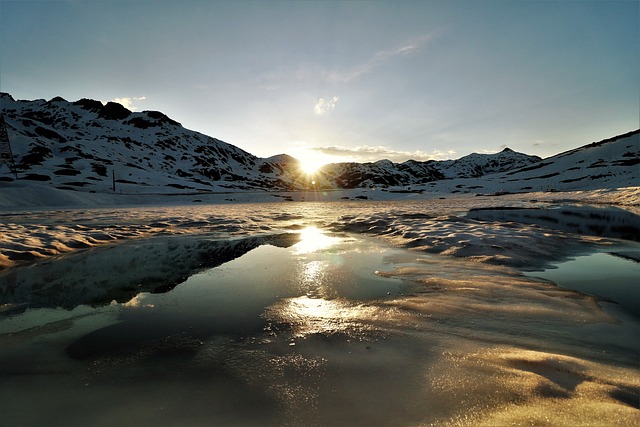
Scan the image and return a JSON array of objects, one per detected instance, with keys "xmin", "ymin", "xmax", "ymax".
[{"xmin": 0, "ymin": 181, "xmax": 640, "ymax": 212}]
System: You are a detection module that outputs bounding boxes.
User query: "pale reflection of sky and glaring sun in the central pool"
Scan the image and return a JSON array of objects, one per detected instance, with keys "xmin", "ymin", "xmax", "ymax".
[{"xmin": 55, "ymin": 229, "xmax": 400, "ymax": 359}]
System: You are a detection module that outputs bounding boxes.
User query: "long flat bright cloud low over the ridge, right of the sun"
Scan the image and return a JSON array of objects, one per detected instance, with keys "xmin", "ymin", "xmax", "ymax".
[{"xmin": 311, "ymin": 145, "xmax": 456, "ymax": 163}]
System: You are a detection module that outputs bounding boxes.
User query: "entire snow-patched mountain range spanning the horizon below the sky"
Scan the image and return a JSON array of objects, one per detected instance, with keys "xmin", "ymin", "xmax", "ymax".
[{"xmin": 0, "ymin": 93, "xmax": 640, "ymax": 193}]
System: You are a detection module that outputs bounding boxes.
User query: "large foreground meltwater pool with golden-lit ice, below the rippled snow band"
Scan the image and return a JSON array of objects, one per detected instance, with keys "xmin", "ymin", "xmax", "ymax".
[{"xmin": 0, "ymin": 228, "xmax": 640, "ymax": 426}]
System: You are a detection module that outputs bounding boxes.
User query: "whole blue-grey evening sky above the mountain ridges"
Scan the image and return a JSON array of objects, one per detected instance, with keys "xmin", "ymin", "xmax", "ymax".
[{"xmin": 0, "ymin": 0, "xmax": 640, "ymax": 162}]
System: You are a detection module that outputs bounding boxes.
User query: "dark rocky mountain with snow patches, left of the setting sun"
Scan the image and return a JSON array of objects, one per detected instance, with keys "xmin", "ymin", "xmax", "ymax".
[{"xmin": 0, "ymin": 93, "xmax": 293, "ymax": 192}]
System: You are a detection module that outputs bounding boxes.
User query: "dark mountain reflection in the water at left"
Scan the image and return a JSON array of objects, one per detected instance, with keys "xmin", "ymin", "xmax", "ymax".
[{"xmin": 0, "ymin": 233, "xmax": 299, "ymax": 314}]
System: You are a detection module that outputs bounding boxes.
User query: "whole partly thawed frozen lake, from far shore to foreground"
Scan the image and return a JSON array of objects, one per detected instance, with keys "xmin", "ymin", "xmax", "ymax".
[{"xmin": 0, "ymin": 201, "xmax": 640, "ymax": 426}]
